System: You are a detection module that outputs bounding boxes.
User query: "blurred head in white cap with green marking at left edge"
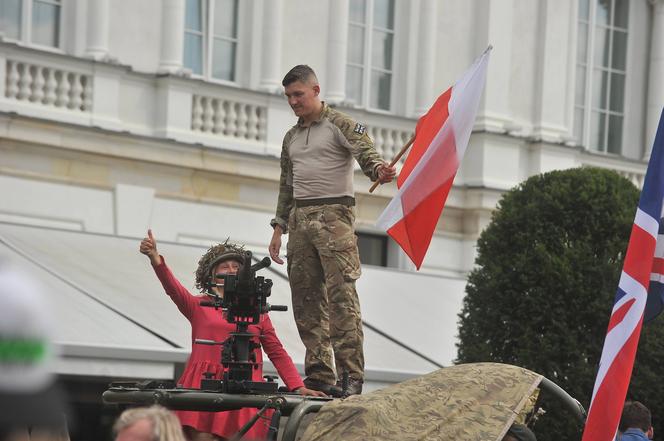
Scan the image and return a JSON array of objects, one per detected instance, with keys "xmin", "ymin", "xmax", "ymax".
[{"xmin": 0, "ymin": 260, "xmax": 66, "ymax": 440}]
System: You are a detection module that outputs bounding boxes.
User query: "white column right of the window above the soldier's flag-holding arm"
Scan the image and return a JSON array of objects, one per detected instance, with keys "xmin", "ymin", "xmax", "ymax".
[{"xmin": 415, "ymin": 0, "xmax": 438, "ymax": 117}]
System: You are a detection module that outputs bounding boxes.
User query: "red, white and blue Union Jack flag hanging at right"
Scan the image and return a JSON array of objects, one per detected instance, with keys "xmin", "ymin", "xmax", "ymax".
[{"xmin": 582, "ymin": 107, "xmax": 664, "ymax": 441}]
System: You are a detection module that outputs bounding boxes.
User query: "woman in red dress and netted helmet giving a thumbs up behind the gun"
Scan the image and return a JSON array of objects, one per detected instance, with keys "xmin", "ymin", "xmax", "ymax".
[{"xmin": 139, "ymin": 230, "xmax": 325, "ymax": 441}]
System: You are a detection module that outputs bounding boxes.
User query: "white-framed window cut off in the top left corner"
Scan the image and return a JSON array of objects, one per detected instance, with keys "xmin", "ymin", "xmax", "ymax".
[{"xmin": 0, "ymin": 0, "xmax": 62, "ymax": 48}]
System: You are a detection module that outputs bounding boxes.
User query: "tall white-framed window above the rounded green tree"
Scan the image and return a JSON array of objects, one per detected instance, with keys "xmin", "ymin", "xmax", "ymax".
[{"xmin": 574, "ymin": 0, "xmax": 629, "ymax": 154}]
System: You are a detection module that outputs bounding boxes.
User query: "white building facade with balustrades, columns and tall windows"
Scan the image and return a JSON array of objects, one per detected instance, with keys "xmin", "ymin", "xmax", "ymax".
[{"xmin": 0, "ymin": 0, "xmax": 664, "ymax": 434}]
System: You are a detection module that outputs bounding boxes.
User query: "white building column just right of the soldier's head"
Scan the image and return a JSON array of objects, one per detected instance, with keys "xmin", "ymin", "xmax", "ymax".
[{"xmin": 324, "ymin": 0, "xmax": 348, "ymax": 104}]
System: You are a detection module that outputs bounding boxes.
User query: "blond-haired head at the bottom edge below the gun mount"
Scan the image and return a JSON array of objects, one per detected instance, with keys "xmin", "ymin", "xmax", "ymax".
[{"xmin": 113, "ymin": 405, "xmax": 185, "ymax": 441}]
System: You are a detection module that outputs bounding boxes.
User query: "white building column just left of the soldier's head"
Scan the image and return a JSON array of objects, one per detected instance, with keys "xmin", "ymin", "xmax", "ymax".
[{"xmin": 259, "ymin": 0, "xmax": 284, "ymax": 93}]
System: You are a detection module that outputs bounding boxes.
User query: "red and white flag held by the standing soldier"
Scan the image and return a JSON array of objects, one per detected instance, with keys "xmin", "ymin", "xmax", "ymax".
[{"xmin": 376, "ymin": 46, "xmax": 492, "ymax": 269}]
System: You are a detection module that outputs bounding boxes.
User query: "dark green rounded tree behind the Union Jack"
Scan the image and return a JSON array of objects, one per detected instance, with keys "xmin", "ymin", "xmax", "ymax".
[{"xmin": 457, "ymin": 168, "xmax": 664, "ymax": 441}]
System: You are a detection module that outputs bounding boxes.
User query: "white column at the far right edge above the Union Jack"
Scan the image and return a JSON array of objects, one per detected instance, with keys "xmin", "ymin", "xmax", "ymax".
[{"xmin": 646, "ymin": 0, "xmax": 664, "ymax": 152}]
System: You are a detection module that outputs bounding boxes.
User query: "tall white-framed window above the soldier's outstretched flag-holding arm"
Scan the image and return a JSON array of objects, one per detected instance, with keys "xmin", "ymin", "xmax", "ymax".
[{"xmin": 346, "ymin": 0, "xmax": 394, "ymax": 110}]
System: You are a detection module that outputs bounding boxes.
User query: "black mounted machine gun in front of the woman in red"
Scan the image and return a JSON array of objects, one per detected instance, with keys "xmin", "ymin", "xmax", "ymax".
[{"xmin": 194, "ymin": 251, "xmax": 288, "ymax": 394}]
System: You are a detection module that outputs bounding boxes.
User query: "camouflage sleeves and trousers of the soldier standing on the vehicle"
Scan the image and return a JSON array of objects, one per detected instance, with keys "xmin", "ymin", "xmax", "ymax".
[{"xmin": 271, "ymin": 103, "xmax": 383, "ymax": 384}]
